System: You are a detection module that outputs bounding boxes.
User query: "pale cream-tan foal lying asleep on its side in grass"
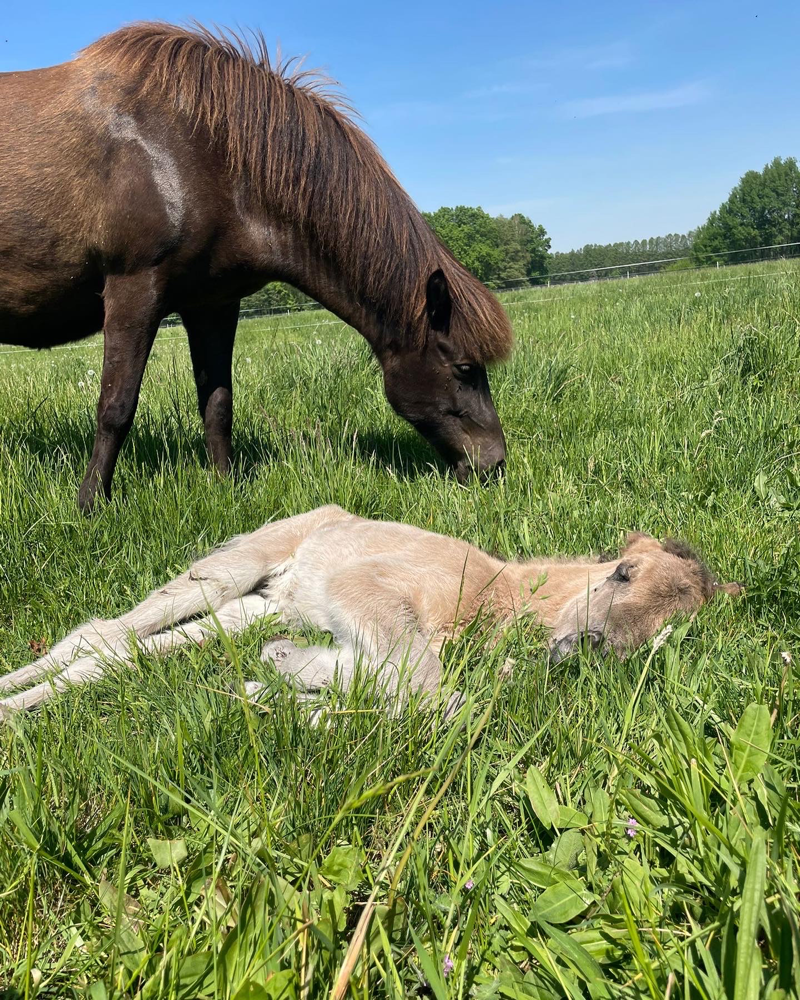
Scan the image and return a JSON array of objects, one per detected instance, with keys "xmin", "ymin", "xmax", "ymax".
[{"xmin": 0, "ymin": 506, "xmax": 740, "ymax": 712}]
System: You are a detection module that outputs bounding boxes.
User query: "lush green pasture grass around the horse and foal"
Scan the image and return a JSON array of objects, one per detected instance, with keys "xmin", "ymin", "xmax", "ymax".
[{"xmin": 0, "ymin": 264, "xmax": 800, "ymax": 1000}]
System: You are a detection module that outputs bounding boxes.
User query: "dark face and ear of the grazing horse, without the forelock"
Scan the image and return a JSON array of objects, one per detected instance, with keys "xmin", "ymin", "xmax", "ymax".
[{"xmin": 380, "ymin": 270, "xmax": 510, "ymax": 482}]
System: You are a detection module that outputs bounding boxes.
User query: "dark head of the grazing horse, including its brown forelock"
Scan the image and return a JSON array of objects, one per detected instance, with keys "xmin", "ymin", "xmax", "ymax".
[{"xmin": 379, "ymin": 269, "xmax": 511, "ymax": 481}]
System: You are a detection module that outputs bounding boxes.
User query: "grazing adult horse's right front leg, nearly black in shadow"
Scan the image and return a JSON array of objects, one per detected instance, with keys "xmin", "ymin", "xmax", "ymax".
[{"xmin": 181, "ymin": 302, "xmax": 239, "ymax": 472}]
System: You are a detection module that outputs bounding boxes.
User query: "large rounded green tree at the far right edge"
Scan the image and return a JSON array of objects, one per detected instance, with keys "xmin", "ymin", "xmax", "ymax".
[{"xmin": 692, "ymin": 156, "xmax": 800, "ymax": 263}]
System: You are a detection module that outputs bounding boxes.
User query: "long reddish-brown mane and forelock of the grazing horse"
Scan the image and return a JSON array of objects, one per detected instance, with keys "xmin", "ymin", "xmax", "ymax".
[{"xmin": 81, "ymin": 23, "xmax": 512, "ymax": 363}]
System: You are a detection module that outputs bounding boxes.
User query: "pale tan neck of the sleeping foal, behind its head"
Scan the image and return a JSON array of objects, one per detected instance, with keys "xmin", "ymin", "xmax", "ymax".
[{"xmin": 504, "ymin": 559, "xmax": 609, "ymax": 625}]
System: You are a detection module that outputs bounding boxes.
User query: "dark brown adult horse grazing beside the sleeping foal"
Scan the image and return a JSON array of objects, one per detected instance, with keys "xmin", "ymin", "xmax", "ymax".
[{"xmin": 0, "ymin": 24, "xmax": 512, "ymax": 509}]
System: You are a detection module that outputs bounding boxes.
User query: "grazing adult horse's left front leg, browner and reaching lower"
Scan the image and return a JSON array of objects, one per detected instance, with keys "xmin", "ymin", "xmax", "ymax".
[{"xmin": 78, "ymin": 270, "xmax": 163, "ymax": 512}]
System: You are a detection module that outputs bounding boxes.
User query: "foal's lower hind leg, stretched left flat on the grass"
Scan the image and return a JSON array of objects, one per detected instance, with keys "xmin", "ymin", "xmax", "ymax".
[{"xmin": 0, "ymin": 594, "xmax": 278, "ymax": 718}]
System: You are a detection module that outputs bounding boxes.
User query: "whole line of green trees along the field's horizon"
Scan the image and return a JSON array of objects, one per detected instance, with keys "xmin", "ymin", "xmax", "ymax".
[{"xmin": 243, "ymin": 157, "xmax": 800, "ymax": 309}]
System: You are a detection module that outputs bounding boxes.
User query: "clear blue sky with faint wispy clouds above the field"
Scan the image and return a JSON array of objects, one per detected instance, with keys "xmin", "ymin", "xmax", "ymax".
[{"xmin": 0, "ymin": 0, "xmax": 800, "ymax": 250}]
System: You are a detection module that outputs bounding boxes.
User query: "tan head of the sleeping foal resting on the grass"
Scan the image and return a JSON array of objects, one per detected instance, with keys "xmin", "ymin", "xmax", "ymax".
[{"xmin": 551, "ymin": 532, "xmax": 742, "ymax": 662}]
